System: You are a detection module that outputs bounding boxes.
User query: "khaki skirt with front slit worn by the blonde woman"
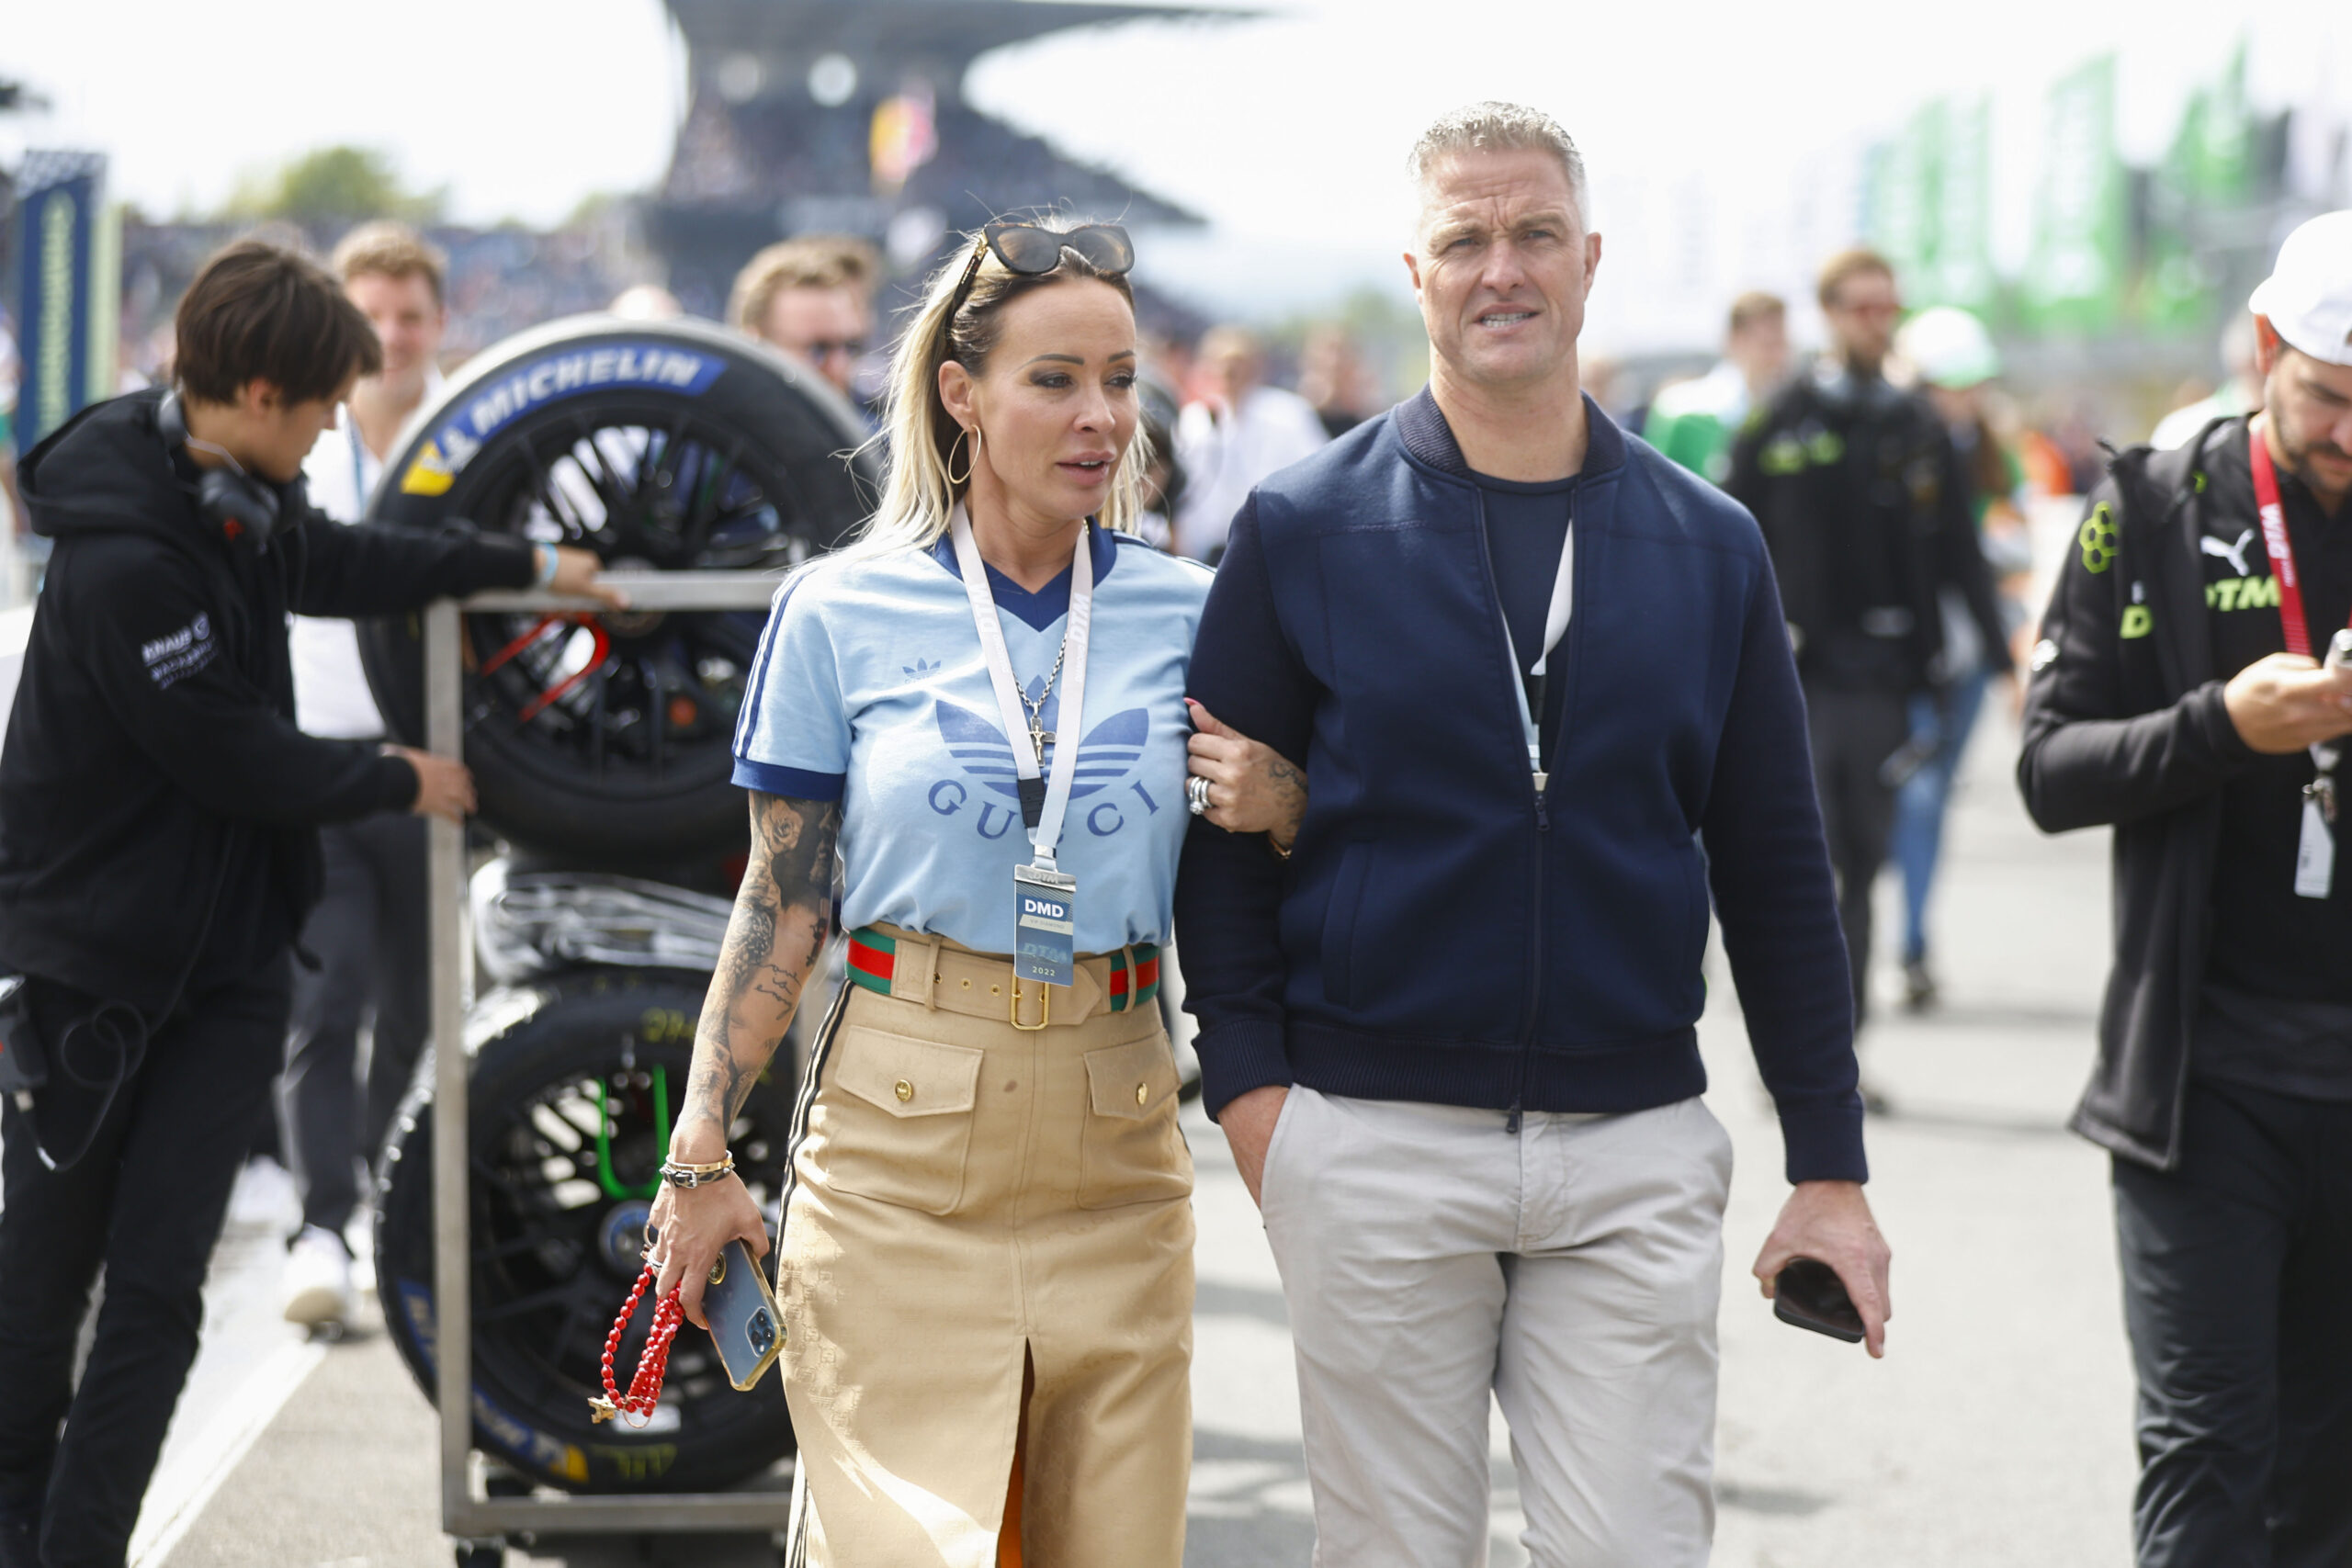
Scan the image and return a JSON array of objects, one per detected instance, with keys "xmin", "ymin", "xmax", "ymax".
[{"xmin": 776, "ymin": 926, "xmax": 1193, "ymax": 1568}]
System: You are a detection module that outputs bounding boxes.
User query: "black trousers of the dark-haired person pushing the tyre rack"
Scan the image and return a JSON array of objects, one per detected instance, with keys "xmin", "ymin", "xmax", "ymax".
[{"xmin": 0, "ymin": 957, "xmax": 289, "ymax": 1568}]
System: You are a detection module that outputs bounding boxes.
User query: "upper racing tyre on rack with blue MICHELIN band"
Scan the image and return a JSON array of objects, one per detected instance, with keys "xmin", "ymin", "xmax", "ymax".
[{"xmin": 360, "ymin": 317, "xmax": 875, "ymax": 865}]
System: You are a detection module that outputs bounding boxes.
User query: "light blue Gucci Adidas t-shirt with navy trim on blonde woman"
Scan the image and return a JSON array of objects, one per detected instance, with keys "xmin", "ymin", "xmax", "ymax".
[{"xmin": 734, "ymin": 525, "xmax": 1209, "ymax": 952}]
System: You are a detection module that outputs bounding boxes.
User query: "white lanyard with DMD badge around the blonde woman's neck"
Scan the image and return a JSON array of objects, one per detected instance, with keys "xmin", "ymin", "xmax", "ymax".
[{"xmin": 948, "ymin": 505, "xmax": 1093, "ymax": 987}]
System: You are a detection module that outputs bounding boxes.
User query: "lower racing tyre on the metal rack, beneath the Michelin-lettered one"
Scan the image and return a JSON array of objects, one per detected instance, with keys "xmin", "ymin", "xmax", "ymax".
[{"xmin": 377, "ymin": 968, "xmax": 793, "ymax": 1493}]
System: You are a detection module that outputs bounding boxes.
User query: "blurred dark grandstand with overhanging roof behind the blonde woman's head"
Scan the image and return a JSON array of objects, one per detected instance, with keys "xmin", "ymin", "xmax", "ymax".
[{"xmin": 642, "ymin": 0, "xmax": 1249, "ymax": 315}]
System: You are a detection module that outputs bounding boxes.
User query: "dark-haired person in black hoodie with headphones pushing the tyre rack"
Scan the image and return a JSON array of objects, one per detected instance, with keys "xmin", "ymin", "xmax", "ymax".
[{"xmin": 0, "ymin": 243, "xmax": 616, "ymax": 1568}]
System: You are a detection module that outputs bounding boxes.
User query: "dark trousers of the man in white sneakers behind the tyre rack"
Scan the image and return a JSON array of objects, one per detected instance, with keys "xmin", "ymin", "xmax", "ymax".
[{"xmin": 277, "ymin": 816, "xmax": 430, "ymax": 1235}]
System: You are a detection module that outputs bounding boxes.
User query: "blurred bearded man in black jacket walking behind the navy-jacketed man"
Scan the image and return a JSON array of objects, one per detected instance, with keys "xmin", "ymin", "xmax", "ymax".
[{"xmin": 1724, "ymin": 249, "xmax": 2011, "ymax": 1022}]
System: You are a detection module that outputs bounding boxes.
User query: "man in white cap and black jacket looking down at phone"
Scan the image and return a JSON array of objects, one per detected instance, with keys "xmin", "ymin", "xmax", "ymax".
[{"xmin": 2018, "ymin": 211, "xmax": 2352, "ymax": 1568}]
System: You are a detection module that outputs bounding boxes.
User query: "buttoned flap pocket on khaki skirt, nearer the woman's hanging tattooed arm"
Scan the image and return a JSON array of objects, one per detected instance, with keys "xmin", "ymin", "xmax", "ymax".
[{"xmin": 819, "ymin": 1025, "xmax": 986, "ymax": 1213}]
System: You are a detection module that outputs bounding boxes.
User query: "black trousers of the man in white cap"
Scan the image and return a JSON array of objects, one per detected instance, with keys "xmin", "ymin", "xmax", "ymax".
[{"xmin": 2114, "ymin": 1081, "xmax": 2352, "ymax": 1568}]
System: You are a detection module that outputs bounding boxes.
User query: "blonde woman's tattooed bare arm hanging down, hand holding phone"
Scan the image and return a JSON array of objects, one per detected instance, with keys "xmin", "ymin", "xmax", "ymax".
[{"xmin": 654, "ymin": 792, "xmax": 842, "ymax": 1325}]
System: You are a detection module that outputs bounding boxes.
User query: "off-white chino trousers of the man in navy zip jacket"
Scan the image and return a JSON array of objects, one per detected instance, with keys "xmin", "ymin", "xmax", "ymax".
[{"xmin": 1261, "ymin": 1089, "xmax": 1731, "ymax": 1568}]
